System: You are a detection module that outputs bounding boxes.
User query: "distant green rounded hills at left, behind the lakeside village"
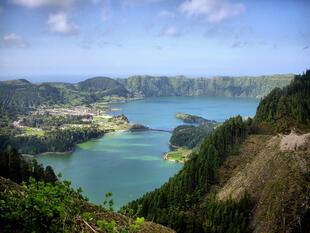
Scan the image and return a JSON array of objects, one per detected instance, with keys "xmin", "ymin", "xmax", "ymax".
[{"xmin": 0, "ymin": 77, "xmax": 130, "ymax": 110}]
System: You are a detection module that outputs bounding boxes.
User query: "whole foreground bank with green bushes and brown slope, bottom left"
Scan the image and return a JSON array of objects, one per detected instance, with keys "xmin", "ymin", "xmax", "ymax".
[{"xmin": 0, "ymin": 175, "xmax": 173, "ymax": 233}]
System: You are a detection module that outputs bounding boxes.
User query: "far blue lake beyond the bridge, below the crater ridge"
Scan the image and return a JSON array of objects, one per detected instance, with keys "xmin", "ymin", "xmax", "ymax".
[{"xmin": 111, "ymin": 96, "xmax": 259, "ymax": 129}]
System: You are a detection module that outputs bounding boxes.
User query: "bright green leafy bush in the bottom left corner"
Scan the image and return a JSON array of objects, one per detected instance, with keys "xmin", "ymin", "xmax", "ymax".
[{"xmin": 0, "ymin": 178, "xmax": 85, "ymax": 232}]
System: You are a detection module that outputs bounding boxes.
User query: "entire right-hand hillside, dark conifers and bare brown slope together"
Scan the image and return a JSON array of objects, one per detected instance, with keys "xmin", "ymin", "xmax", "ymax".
[{"xmin": 124, "ymin": 71, "xmax": 310, "ymax": 232}]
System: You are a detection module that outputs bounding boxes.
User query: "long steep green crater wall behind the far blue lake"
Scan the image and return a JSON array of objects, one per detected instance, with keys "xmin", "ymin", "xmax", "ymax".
[{"xmin": 117, "ymin": 74, "xmax": 294, "ymax": 98}]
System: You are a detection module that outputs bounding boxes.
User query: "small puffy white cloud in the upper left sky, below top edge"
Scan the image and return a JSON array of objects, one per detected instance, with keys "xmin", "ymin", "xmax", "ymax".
[{"xmin": 46, "ymin": 12, "xmax": 78, "ymax": 35}]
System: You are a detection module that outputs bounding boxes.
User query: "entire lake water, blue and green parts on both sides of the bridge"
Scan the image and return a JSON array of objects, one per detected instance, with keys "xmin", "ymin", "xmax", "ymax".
[{"xmin": 37, "ymin": 97, "xmax": 258, "ymax": 208}]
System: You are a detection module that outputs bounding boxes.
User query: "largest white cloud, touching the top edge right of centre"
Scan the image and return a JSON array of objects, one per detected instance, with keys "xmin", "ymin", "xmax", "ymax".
[{"xmin": 179, "ymin": 0, "xmax": 245, "ymax": 22}]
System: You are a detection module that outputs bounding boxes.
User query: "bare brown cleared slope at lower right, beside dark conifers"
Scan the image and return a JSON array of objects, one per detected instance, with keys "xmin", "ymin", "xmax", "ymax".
[{"xmin": 217, "ymin": 134, "xmax": 310, "ymax": 232}]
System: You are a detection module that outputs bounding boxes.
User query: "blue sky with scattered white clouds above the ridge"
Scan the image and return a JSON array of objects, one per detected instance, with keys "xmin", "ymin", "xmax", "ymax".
[{"xmin": 0, "ymin": 0, "xmax": 310, "ymax": 81}]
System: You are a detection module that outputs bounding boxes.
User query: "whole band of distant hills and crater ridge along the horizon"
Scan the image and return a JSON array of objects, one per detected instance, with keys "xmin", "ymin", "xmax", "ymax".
[{"xmin": 0, "ymin": 74, "xmax": 293, "ymax": 113}]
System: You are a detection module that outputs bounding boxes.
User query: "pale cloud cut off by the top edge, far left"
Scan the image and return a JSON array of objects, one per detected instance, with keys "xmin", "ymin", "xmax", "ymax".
[{"xmin": 12, "ymin": 0, "xmax": 76, "ymax": 8}]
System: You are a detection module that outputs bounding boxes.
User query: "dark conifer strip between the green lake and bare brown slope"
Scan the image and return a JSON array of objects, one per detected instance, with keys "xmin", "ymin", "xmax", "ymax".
[{"xmin": 123, "ymin": 116, "xmax": 251, "ymax": 232}]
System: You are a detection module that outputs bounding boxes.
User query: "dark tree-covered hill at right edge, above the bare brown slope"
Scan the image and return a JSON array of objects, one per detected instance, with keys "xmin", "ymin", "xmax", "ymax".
[{"xmin": 254, "ymin": 70, "xmax": 310, "ymax": 132}]
